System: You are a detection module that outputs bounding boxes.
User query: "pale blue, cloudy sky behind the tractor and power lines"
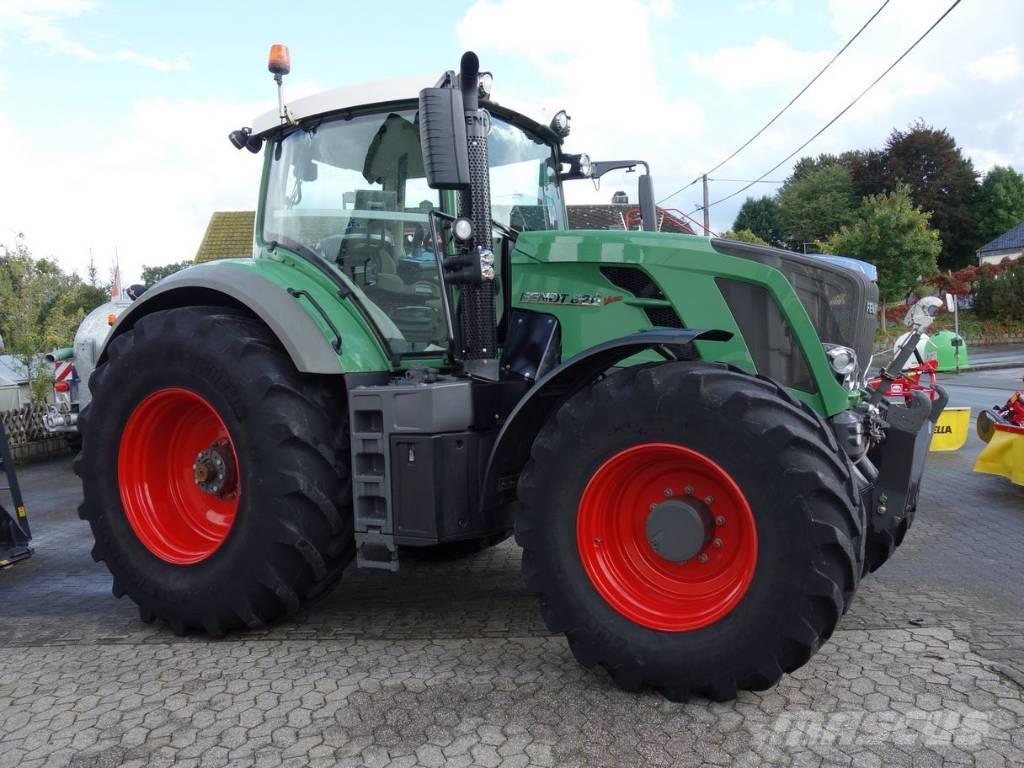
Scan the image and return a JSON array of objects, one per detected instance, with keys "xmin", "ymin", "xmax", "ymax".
[{"xmin": 0, "ymin": 0, "xmax": 1024, "ymax": 282}]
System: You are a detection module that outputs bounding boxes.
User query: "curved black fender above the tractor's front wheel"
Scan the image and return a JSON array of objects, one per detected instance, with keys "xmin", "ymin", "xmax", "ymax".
[{"xmin": 480, "ymin": 329, "xmax": 732, "ymax": 507}]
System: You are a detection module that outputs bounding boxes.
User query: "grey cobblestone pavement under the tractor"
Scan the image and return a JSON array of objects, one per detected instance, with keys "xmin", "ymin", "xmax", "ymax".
[{"xmin": 0, "ymin": 405, "xmax": 1024, "ymax": 768}]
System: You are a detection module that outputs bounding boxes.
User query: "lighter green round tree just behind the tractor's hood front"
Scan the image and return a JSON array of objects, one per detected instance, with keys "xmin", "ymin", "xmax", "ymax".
[{"xmin": 827, "ymin": 185, "xmax": 942, "ymax": 303}]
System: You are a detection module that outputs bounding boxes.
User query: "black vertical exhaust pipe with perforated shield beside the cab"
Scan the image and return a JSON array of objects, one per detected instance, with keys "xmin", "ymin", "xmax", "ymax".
[{"xmin": 459, "ymin": 51, "xmax": 497, "ymax": 380}]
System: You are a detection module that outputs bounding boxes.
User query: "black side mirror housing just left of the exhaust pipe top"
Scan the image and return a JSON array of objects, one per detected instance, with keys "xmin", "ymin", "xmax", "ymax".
[{"xmin": 420, "ymin": 88, "xmax": 469, "ymax": 189}]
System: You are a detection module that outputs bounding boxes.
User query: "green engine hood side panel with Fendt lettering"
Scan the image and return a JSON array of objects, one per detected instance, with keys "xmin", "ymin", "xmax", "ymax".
[{"xmin": 512, "ymin": 230, "xmax": 851, "ymax": 417}]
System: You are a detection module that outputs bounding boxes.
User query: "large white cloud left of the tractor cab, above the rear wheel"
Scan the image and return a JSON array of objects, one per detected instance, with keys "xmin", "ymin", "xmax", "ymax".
[{"xmin": 0, "ymin": 75, "xmax": 323, "ymax": 282}]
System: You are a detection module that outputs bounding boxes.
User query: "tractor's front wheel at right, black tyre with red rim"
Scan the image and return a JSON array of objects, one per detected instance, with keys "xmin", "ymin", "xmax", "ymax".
[{"xmin": 516, "ymin": 362, "xmax": 863, "ymax": 700}]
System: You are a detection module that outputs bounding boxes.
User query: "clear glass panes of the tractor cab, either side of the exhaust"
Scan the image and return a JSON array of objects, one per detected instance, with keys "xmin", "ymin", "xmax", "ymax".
[{"xmin": 262, "ymin": 111, "xmax": 565, "ymax": 354}]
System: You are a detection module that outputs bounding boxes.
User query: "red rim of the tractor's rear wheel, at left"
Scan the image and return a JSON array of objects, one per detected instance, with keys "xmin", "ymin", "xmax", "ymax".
[{"xmin": 118, "ymin": 387, "xmax": 241, "ymax": 565}]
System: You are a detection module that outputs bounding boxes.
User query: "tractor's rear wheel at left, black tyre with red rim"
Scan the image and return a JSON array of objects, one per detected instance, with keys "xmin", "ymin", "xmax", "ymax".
[{"xmin": 76, "ymin": 307, "xmax": 354, "ymax": 636}]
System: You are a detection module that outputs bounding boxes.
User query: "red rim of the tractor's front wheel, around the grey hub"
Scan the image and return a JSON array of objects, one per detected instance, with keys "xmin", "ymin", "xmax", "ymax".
[{"xmin": 577, "ymin": 442, "xmax": 758, "ymax": 632}]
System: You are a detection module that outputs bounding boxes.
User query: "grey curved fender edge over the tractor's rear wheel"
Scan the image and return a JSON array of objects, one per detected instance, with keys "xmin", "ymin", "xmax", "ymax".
[{"xmin": 97, "ymin": 263, "xmax": 342, "ymax": 374}]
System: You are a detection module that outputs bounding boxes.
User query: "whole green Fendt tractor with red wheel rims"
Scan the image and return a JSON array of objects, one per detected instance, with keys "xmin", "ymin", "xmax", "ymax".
[{"xmin": 77, "ymin": 47, "xmax": 941, "ymax": 699}]
